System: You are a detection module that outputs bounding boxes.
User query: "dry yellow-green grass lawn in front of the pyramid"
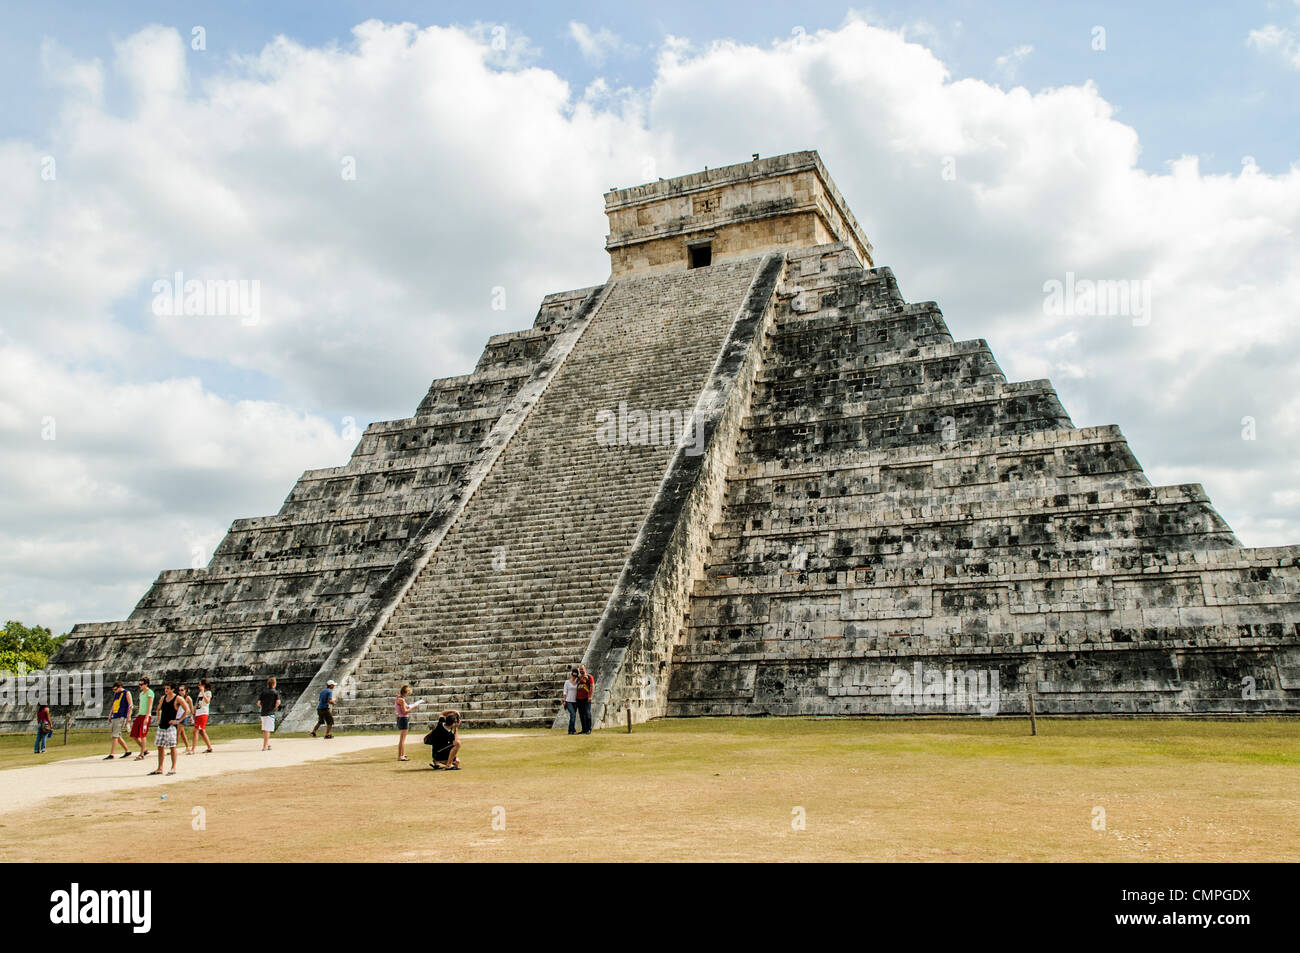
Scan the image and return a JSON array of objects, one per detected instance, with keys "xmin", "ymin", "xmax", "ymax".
[{"xmin": 0, "ymin": 719, "xmax": 1300, "ymax": 862}]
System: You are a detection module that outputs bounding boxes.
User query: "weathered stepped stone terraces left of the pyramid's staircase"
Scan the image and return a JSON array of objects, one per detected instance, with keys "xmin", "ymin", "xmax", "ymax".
[{"xmin": 0, "ymin": 289, "xmax": 592, "ymax": 728}]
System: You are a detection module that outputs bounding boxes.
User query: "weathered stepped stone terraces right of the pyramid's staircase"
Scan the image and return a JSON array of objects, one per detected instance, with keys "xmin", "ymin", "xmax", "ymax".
[{"xmin": 667, "ymin": 248, "xmax": 1300, "ymax": 715}]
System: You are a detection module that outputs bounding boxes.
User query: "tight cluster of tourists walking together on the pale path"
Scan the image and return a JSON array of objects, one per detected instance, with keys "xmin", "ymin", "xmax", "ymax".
[{"xmin": 104, "ymin": 676, "xmax": 213, "ymax": 775}]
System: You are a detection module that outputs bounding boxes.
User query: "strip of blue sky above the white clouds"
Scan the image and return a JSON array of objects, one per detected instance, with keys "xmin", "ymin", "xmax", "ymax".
[{"xmin": 0, "ymin": 0, "xmax": 1300, "ymax": 172}]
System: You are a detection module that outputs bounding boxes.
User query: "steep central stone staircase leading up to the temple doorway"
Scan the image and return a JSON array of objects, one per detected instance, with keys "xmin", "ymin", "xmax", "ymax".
[{"xmin": 330, "ymin": 260, "xmax": 758, "ymax": 727}]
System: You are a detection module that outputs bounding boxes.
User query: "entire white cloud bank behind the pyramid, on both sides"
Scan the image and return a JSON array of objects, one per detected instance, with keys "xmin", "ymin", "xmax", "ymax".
[{"xmin": 0, "ymin": 17, "xmax": 1300, "ymax": 628}]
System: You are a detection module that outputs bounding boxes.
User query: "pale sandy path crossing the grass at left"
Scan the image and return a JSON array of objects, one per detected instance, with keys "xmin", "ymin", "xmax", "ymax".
[{"xmin": 0, "ymin": 732, "xmax": 520, "ymax": 814}]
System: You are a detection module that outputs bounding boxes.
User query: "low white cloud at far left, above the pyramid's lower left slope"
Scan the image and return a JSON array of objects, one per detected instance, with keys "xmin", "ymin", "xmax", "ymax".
[{"xmin": 0, "ymin": 345, "xmax": 355, "ymax": 629}]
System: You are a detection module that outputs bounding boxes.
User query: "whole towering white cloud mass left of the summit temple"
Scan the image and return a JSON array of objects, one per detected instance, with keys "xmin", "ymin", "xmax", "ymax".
[{"xmin": 0, "ymin": 22, "xmax": 651, "ymax": 627}]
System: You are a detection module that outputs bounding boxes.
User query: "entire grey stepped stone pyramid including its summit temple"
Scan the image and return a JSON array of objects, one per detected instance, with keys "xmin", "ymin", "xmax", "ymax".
[{"xmin": 10, "ymin": 152, "xmax": 1300, "ymax": 729}]
